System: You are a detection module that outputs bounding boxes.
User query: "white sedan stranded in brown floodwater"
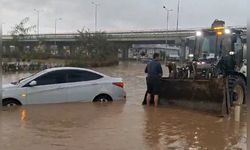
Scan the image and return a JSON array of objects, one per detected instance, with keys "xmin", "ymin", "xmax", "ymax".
[{"xmin": 2, "ymin": 67, "xmax": 126, "ymax": 106}]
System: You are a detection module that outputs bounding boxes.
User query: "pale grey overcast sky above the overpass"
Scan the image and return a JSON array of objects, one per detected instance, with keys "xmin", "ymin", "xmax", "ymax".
[{"xmin": 0, "ymin": 0, "xmax": 247, "ymax": 33}]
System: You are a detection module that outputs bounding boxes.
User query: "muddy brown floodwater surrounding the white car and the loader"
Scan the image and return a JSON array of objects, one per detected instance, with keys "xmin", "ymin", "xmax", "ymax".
[{"xmin": 0, "ymin": 62, "xmax": 247, "ymax": 150}]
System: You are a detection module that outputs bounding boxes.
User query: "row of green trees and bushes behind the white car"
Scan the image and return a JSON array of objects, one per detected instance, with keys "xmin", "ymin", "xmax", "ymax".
[{"xmin": 5, "ymin": 20, "xmax": 118, "ymax": 67}]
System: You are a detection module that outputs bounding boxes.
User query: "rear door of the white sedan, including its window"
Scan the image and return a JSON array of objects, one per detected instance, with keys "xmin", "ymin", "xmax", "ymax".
[{"xmin": 67, "ymin": 70, "xmax": 103, "ymax": 102}]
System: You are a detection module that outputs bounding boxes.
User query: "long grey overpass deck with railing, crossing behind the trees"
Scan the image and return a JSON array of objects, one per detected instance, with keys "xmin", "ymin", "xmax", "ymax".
[{"xmin": 3, "ymin": 30, "xmax": 195, "ymax": 42}]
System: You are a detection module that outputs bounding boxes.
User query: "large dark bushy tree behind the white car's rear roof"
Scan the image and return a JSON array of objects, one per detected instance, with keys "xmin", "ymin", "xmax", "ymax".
[{"xmin": 71, "ymin": 29, "xmax": 118, "ymax": 66}]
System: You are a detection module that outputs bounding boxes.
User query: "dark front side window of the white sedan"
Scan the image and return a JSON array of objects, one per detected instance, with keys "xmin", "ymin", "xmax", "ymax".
[{"xmin": 35, "ymin": 70, "xmax": 66, "ymax": 86}]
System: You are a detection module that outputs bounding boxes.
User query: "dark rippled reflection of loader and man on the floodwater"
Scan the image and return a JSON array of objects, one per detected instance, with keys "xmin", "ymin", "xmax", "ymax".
[{"xmin": 143, "ymin": 107, "xmax": 246, "ymax": 149}]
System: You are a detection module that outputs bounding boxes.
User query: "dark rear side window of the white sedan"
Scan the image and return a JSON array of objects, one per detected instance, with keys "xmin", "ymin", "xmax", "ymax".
[{"xmin": 68, "ymin": 70, "xmax": 102, "ymax": 82}]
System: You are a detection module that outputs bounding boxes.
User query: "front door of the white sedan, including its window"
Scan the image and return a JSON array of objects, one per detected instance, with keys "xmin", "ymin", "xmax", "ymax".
[{"xmin": 27, "ymin": 70, "xmax": 67, "ymax": 104}]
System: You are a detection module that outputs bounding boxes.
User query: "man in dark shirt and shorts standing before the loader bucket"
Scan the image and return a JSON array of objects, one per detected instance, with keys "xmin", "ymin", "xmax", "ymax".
[{"xmin": 145, "ymin": 53, "xmax": 162, "ymax": 107}]
